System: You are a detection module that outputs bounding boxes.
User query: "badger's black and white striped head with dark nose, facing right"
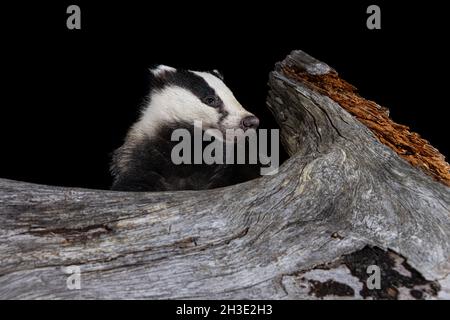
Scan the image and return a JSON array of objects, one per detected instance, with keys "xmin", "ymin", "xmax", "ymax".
[{"xmin": 139, "ymin": 65, "xmax": 259, "ymax": 140}]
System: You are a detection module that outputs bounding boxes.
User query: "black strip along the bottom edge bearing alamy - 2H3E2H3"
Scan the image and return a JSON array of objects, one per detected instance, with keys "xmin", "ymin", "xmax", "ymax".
[{"xmin": 0, "ymin": 300, "xmax": 442, "ymax": 320}]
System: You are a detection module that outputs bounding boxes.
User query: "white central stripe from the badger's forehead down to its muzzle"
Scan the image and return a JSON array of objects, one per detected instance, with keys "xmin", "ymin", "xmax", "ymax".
[{"xmin": 192, "ymin": 71, "xmax": 253, "ymax": 129}]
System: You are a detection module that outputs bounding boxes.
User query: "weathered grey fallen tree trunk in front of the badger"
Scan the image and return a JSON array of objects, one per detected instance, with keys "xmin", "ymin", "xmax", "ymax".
[{"xmin": 0, "ymin": 51, "xmax": 450, "ymax": 299}]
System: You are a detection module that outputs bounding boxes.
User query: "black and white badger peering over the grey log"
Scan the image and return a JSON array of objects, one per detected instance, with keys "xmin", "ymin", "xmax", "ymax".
[{"xmin": 111, "ymin": 65, "xmax": 259, "ymax": 191}]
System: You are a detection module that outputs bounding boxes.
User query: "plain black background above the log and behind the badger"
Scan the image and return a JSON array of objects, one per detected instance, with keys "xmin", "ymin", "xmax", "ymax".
[{"xmin": 0, "ymin": 0, "xmax": 450, "ymax": 188}]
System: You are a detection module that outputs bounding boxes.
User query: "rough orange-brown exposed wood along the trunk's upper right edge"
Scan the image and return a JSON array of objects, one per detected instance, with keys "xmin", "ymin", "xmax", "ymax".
[{"xmin": 281, "ymin": 65, "xmax": 450, "ymax": 186}]
